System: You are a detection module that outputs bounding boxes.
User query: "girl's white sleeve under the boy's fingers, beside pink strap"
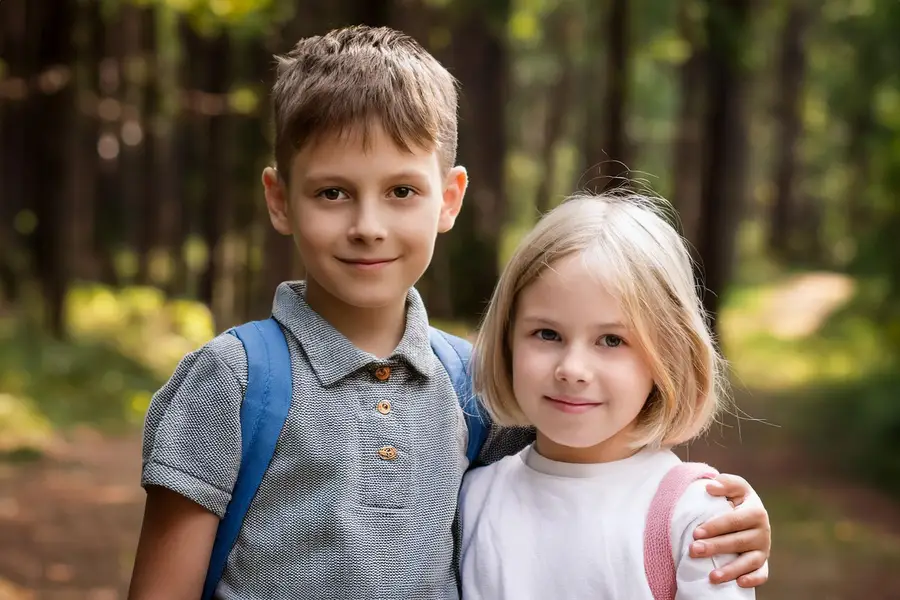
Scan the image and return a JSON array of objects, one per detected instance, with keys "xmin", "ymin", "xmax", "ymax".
[{"xmin": 671, "ymin": 480, "xmax": 756, "ymax": 600}]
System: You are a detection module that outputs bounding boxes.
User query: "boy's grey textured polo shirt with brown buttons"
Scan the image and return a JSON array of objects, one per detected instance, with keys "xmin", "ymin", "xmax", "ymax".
[{"xmin": 142, "ymin": 282, "xmax": 533, "ymax": 600}]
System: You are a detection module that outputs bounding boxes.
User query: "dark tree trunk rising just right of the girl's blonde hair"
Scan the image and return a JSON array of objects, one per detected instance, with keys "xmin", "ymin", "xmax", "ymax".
[{"xmin": 698, "ymin": 0, "xmax": 749, "ymax": 325}]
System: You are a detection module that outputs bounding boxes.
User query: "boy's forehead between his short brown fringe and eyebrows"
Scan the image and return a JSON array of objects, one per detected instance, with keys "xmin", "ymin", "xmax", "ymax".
[{"xmin": 291, "ymin": 121, "xmax": 440, "ymax": 177}]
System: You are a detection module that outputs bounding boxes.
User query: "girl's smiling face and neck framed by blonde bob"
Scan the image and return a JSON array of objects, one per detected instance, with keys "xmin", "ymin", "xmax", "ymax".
[{"xmin": 510, "ymin": 255, "xmax": 653, "ymax": 463}]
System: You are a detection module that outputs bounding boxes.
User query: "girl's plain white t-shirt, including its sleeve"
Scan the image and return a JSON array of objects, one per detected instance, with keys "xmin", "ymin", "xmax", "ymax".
[{"xmin": 460, "ymin": 447, "xmax": 755, "ymax": 600}]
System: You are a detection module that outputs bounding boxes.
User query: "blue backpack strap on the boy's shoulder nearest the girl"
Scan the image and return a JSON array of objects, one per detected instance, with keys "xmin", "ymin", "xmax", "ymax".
[{"xmin": 429, "ymin": 327, "xmax": 488, "ymax": 465}]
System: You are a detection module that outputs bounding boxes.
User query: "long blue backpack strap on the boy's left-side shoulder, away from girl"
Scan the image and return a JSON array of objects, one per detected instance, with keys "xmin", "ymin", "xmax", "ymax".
[{"xmin": 202, "ymin": 318, "xmax": 291, "ymax": 600}]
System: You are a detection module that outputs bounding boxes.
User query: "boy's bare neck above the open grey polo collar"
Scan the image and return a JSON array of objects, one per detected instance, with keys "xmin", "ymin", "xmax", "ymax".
[{"xmin": 306, "ymin": 278, "xmax": 406, "ymax": 358}]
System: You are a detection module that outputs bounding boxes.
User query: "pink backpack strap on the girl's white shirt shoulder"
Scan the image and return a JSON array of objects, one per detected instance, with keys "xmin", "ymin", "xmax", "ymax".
[{"xmin": 644, "ymin": 463, "xmax": 719, "ymax": 600}]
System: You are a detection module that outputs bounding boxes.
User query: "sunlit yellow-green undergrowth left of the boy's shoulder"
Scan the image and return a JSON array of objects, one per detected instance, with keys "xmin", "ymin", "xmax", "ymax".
[{"xmin": 0, "ymin": 286, "xmax": 214, "ymax": 451}]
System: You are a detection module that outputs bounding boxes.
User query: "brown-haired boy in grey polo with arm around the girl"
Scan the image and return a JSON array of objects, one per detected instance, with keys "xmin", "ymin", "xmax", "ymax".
[{"xmin": 130, "ymin": 27, "xmax": 769, "ymax": 600}]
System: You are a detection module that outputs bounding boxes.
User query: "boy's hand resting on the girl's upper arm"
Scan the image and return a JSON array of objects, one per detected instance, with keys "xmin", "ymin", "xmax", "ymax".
[{"xmin": 691, "ymin": 474, "xmax": 772, "ymax": 588}]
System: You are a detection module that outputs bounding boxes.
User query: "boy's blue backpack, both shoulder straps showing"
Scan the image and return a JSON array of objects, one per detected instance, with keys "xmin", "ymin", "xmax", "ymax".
[{"xmin": 202, "ymin": 317, "xmax": 488, "ymax": 600}]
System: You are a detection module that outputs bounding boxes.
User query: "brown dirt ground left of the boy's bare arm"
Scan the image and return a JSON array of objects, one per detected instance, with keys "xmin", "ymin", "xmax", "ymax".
[{"xmin": 0, "ymin": 432, "xmax": 143, "ymax": 600}]
